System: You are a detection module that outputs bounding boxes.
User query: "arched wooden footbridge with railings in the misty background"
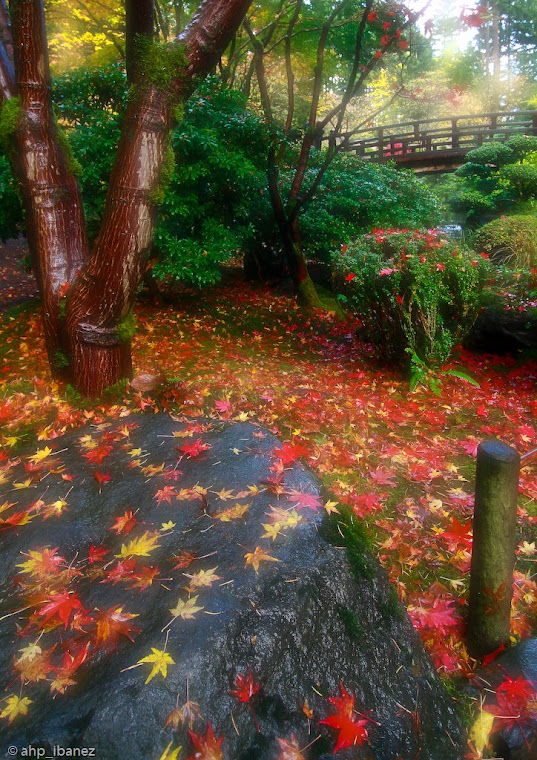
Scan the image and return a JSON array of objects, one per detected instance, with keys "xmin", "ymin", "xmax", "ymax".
[{"xmin": 319, "ymin": 111, "xmax": 537, "ymax": 174}]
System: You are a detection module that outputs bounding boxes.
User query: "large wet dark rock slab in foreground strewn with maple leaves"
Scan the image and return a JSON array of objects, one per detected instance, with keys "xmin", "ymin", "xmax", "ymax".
[{"xmin": 0, "ymin": 415, "xmax": 464, "ymax": 760}]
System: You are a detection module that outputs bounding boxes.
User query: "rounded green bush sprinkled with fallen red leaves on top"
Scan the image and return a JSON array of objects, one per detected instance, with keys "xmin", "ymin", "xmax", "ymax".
[{"xmin": 333, "ymin": 230, "xmax": 488, "ymax": 368}]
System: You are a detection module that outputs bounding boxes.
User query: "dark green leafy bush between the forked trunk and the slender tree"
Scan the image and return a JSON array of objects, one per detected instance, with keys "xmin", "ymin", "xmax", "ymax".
[{"xmin": 153, "ymin": 77, "xmax": 274, "ymax": 287}]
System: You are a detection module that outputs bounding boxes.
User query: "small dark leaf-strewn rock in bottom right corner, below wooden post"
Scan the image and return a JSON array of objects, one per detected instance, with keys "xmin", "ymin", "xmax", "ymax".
[{"xmin": 471, "ymin": 639, "xmax": 537, "ymax": 760}]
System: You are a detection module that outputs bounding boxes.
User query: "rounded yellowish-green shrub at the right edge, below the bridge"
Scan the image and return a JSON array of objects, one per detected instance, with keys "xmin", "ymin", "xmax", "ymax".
[{"xmin": 475, "ymin": 215, "xmax": 537, "ymax": 269}]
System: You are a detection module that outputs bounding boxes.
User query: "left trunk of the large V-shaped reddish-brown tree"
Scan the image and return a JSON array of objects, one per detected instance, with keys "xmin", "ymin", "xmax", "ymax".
[{"xmin": 10, "ymin": 0, "xmax": 87, "ymax": 377}]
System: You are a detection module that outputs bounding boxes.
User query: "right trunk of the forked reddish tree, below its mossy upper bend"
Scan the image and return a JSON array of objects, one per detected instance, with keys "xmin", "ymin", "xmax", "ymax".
[{"xmin": 67, "ymin": 85, "xmax": 171, "ymax": 396}]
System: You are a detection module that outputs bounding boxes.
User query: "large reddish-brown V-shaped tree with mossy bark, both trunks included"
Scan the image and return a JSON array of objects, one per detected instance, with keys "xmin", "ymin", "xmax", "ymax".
[{"xmin": 0, "ymin": 0, "xmax": 249, "ymax": 395}]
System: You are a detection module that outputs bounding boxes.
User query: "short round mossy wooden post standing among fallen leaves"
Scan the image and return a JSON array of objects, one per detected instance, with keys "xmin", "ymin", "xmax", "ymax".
[{"xmin": 468, "ymin": 440, "xmax": 520, "ymax": 658}]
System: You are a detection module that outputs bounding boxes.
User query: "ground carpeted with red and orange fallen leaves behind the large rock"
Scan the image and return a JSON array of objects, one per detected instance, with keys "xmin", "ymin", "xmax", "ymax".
[{"xmin": 0, "ymin": 244, "xmax": 537, "ymax": 675}]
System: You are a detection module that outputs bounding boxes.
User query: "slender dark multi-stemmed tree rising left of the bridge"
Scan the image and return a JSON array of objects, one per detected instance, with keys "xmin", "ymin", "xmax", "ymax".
[{"xmin": 245, "ymin": 0, "xmax": 422, "ymax": 306}]
